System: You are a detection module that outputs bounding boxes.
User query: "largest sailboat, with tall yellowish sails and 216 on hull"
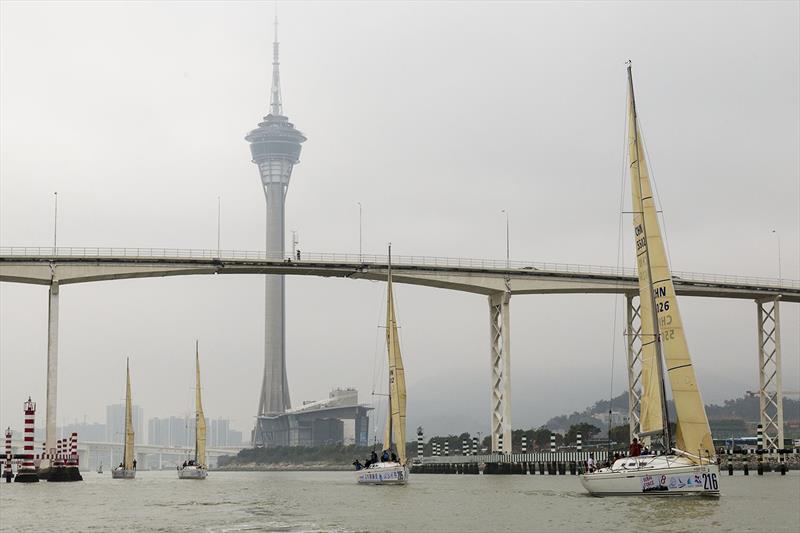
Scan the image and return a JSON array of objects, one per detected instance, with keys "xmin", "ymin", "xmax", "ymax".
[{"xmin": 581, "ymin": 62, "xmax": 720, "ymax": 496}]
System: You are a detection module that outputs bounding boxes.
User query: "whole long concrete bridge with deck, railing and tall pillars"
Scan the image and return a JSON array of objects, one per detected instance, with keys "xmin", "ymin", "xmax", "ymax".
[{"xmin": 0, "ymin": 247, "xmax": 800, "ymax": 458}]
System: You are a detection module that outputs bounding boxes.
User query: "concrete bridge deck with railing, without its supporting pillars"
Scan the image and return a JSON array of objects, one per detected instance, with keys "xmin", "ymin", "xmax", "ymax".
[{"xmin": 0, "ymin": 247, "xmax": 800, "ymax": 302}]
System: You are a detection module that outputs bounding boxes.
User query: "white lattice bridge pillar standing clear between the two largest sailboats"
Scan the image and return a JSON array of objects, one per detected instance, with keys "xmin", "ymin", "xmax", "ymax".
[{"xmin": 489, "ymin": 291, "xmax": 511, "ymax": 452}]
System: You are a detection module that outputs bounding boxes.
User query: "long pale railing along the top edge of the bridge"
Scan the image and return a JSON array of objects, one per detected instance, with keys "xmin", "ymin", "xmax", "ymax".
[{"xmin": 0, "ymin": 246, "xmax": 800, "ymax": 289}]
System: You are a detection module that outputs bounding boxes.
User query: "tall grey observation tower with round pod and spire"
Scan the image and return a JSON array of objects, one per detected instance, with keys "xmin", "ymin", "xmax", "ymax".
[{"xmin": 245, "ymin": 17, "xmax": 306, "ymax": 446}]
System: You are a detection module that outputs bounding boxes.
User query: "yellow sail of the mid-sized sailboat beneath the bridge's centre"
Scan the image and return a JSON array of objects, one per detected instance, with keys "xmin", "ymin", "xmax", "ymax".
[{"xmin": 383, "ymin": 247, "xmax": 406, "ymax": 464}]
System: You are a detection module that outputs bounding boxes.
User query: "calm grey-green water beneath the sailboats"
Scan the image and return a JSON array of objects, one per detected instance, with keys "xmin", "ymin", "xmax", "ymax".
[{"xmin": 0, "ymin": 472, "xmax": 800, "ymax": 533}]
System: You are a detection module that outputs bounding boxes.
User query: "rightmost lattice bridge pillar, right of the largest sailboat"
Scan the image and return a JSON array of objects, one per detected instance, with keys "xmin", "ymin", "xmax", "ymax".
[{"xmin": 756, "ymin": 298, "xmax": 783, "ymax": 452}]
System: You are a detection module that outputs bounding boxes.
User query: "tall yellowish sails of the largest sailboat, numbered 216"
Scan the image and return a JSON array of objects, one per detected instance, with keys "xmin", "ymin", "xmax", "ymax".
[{"xmin": 628, "ymin": 66, "xmax": 714, "ymax": 457}]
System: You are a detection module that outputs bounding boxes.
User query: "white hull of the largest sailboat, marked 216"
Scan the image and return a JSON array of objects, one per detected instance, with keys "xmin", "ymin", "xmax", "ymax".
[{"xmin": 581, "ymin": 455, "xmax": 720, "ymax": 496}]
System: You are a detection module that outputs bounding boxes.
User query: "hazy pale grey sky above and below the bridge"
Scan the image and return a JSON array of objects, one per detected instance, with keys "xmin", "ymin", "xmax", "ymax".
[{"xmin": 0, "ymin": 2, "xmax": 800, "ymax": 433}]
